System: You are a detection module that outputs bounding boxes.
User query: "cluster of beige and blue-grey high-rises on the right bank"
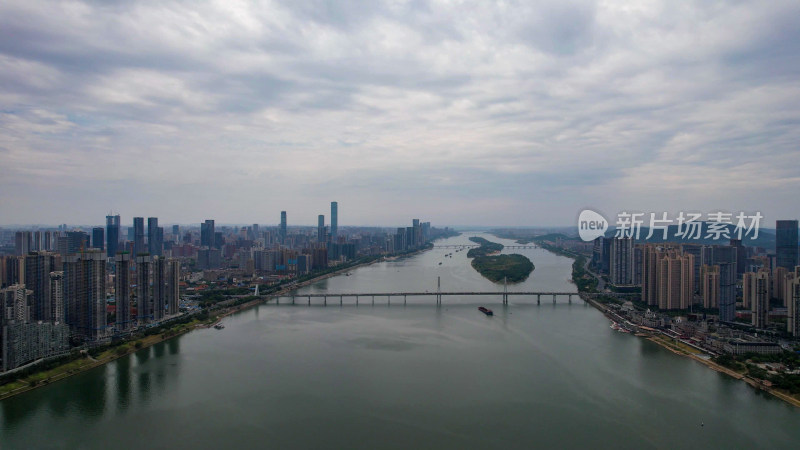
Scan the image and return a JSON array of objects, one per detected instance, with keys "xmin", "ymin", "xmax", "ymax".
[{"xmin": 591, "ymin": 220, "xmax": 800, "ymax": 336}]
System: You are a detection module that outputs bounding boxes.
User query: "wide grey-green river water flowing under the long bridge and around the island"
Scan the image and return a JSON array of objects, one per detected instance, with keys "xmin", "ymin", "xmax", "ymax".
[{"xmin": 0, "ymin": 233, "xmax": 800, "ymax": 450}]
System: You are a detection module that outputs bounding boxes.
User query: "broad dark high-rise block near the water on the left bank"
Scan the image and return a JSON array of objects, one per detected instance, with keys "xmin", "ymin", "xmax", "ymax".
[{"xmin": 64, "ymin": 250, "xmax": 106, "ymax": 340}]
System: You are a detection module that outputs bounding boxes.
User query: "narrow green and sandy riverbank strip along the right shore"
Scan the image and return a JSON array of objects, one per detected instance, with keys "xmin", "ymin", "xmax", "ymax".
[{"xmin": 537, "ymin": 244, "xmax": 800, "ymax": 408}]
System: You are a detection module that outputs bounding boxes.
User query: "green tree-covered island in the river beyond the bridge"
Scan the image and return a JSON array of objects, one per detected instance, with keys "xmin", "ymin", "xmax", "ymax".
[{"xmin": 467, "ymin": 237, "xmax": 534, "ymax": 283}]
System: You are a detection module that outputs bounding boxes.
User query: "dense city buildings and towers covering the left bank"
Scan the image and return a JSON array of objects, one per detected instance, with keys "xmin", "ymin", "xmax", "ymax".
[{"xmin": 0, "ymin": 202, "xmax": 449, "ymax": 371}]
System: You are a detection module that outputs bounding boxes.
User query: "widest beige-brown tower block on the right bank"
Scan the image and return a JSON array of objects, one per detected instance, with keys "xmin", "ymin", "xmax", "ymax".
[{"xmin": 657, "ymin": 250, "xmax": 694, "ymax": 309}]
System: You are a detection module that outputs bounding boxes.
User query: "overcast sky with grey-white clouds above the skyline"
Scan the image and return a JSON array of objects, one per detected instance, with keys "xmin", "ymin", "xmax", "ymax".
[{"xmin": 0, "ymin": 0, "xmax": 800, "ymax": 226}]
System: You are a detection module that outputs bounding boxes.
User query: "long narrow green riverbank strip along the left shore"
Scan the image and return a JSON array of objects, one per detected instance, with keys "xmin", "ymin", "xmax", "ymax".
[{"xmin": 0, "ymin": 247, "xmax": 430, "ymax": 400}]
